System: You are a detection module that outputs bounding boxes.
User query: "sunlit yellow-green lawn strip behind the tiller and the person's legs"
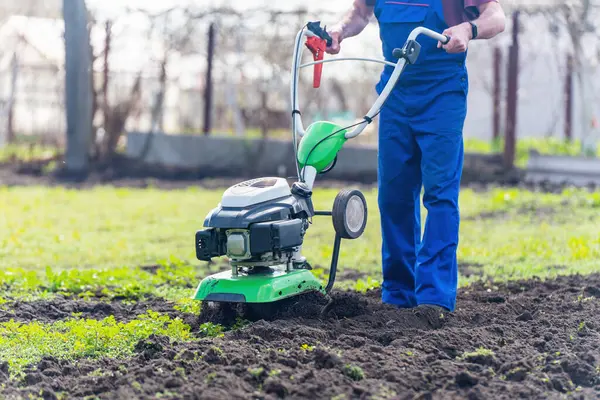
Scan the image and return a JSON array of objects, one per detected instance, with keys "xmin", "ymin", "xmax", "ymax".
[{"xmin": 0, "ymin": 187, "xmax": 600, "ymax": 293}]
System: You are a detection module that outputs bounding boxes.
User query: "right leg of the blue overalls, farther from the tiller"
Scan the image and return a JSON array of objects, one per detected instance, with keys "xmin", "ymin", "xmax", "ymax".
[{"xmin": 411, "ymin": 93, "xmax": 466, "ymax": 311}]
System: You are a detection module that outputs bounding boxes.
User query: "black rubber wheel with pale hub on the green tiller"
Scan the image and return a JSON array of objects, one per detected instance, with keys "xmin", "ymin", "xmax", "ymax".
[{"xmin": 331, "ymin": 189, "xmax": 367, "ymax": 239}]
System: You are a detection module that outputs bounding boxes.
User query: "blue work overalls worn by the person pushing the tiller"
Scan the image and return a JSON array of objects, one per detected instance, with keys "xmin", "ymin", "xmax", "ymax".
[{"xmin": 375, "ymin": 0, "xmax": 468, "ymax": 311}]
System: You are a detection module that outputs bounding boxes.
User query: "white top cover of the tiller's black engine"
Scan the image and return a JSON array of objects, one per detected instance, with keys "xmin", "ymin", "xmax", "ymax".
[{"xmin": 221, "ymin": 177, "xmax": 292, "ymax": 207}]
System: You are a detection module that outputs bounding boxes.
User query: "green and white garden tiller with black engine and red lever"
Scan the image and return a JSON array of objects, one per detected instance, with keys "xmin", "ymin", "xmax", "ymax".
[{"xmin": 194, "ymin": 22, "xmax": 450, "ymax": 303}]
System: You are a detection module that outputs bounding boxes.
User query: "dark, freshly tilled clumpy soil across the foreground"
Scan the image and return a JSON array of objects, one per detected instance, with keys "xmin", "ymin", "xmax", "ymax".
[{"xmin": 0, "ymin": 274, "xmax": 600, "ymax": 400}]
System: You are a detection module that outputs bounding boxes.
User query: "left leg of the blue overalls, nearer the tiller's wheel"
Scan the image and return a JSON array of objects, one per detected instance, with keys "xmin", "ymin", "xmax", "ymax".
[{"xmin": 378, "ymin": 103, "xmax": 421, "ymax": 307}]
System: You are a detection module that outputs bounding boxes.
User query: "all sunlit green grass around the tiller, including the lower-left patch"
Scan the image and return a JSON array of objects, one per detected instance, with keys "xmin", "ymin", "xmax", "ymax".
[{"xmin": 0, "ymin": 187, "xmax": 600, "ymax": 376}]
